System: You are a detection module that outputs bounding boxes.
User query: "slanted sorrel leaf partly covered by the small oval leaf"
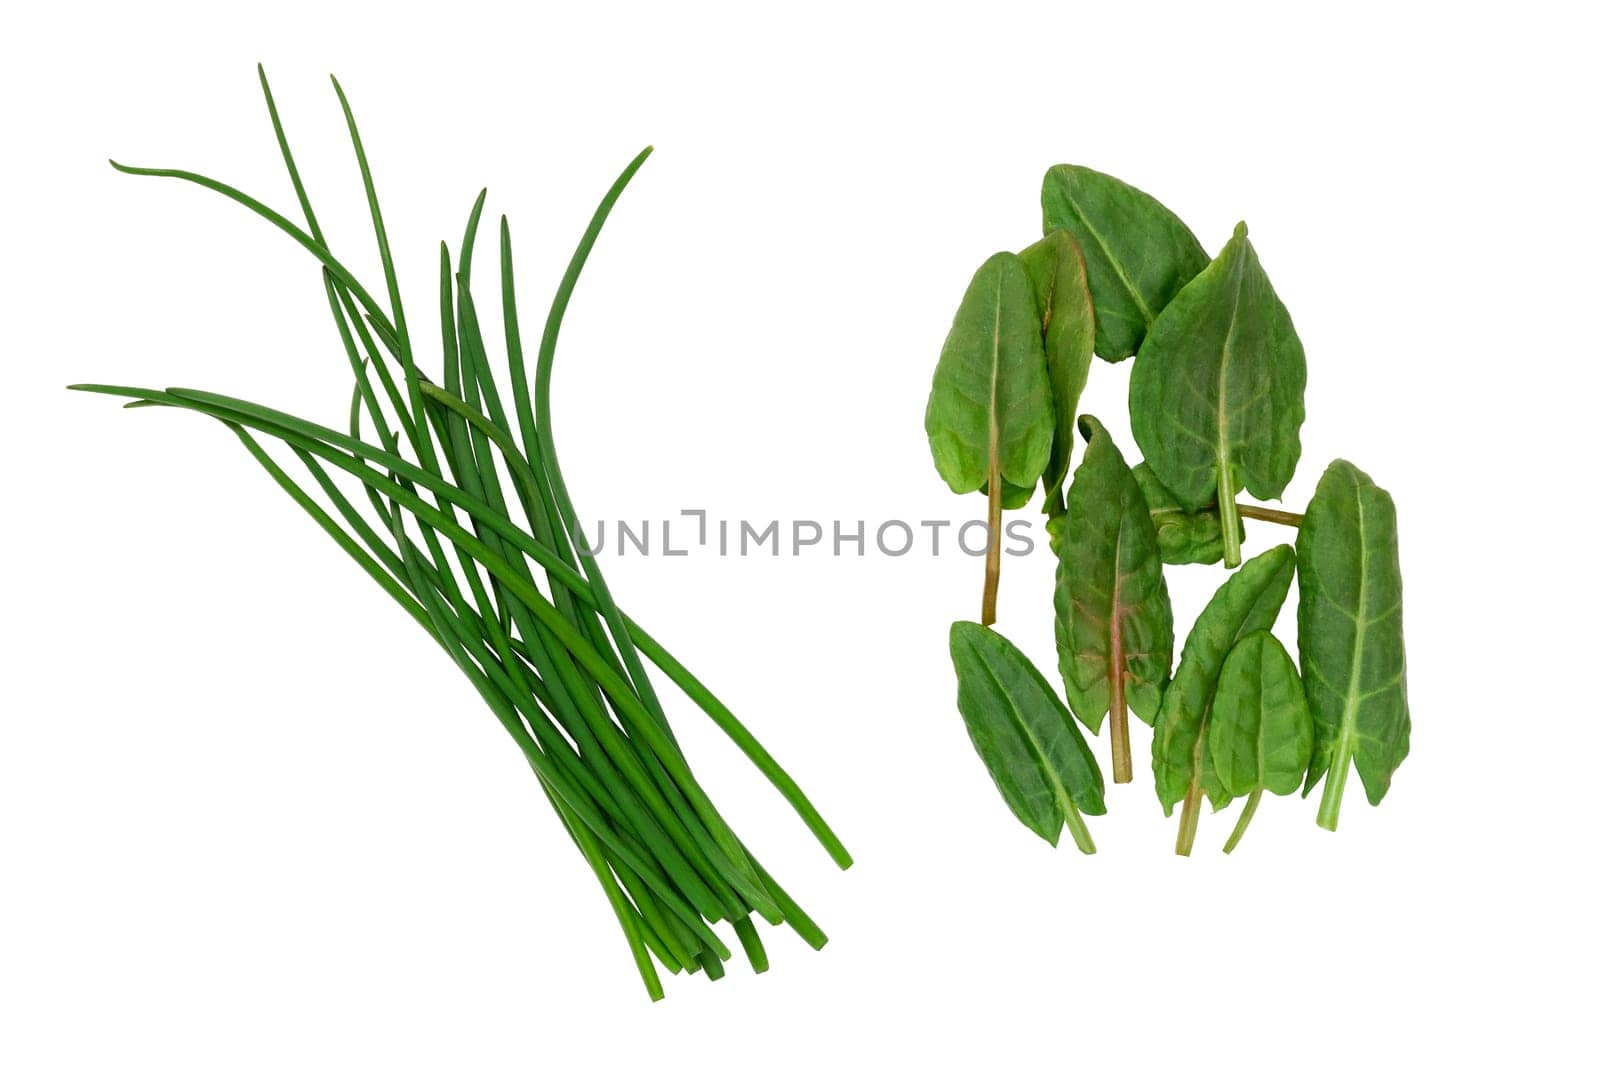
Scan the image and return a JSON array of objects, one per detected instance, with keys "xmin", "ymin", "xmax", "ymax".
[{"xmin": 1150, "ymin": 544, "xmax": 1294, "ymax": 814}]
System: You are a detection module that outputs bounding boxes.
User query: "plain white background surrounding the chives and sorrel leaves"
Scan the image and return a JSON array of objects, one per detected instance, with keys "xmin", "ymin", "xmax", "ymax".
[{"xmin": 0, "ymin": 2, "xmax": 1600, "ymax": 1064}]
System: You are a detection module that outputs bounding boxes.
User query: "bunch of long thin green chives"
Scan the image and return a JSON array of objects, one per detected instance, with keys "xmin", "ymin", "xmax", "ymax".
[{"xmin": 72, "ymin": 69, "xmax": 851, "ymax": 1000}]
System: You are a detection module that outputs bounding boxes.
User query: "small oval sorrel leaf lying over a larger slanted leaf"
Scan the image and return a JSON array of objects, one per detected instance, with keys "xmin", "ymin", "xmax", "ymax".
[{"xmin": 1206, "ymin": 630, "xmax": 1312, "ymax": 853}]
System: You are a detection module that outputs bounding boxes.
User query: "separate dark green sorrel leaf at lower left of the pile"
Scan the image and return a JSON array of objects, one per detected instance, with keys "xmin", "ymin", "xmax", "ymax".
[{"xmin": 950, "ymin": 622, "xmax": 1106, "ymax": 853}]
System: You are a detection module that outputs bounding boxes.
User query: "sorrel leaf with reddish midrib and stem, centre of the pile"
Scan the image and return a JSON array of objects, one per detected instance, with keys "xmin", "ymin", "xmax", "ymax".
[{"xmin": 1056, "ymin": 414, "xmax": 1173, "ymax": 782}]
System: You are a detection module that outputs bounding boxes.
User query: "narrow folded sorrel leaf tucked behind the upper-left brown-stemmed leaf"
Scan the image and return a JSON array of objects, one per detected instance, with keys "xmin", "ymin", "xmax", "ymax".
[{"xmin": 1022, "ymin": 230, "xmax": 1094, "ymax": 514}]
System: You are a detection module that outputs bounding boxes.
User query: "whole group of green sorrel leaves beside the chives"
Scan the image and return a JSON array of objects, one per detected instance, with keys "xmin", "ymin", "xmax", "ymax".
[{"xmin": 926, "ymin": 165, "xmax": 1411, "ymax": 856}]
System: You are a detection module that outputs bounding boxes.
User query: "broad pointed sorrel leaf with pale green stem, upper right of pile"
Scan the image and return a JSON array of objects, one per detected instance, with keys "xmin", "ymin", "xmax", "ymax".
[{"xmin": 1128, "ymin": 222, "xmax": 1306, "ymax": 566}]
